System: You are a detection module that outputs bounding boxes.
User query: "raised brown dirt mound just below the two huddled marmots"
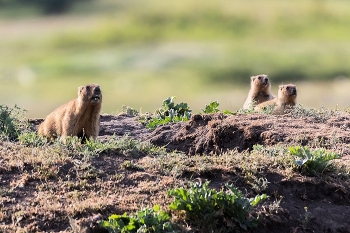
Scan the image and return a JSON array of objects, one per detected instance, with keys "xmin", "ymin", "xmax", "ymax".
[{"xmin": 148, "ymin": 114, "xmax": 350, "ymax": 155}]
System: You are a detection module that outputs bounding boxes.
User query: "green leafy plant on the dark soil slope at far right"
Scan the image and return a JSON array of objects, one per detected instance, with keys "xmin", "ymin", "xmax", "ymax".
[{"xmin": 289, "ymin": 146, "xmax": 341, "ymax": 176}]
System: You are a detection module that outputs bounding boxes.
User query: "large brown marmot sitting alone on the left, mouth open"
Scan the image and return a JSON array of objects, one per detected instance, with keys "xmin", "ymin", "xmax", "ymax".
[{"xmin": 38, "ymin": 84, "xmax": 102, "ymax": 142}]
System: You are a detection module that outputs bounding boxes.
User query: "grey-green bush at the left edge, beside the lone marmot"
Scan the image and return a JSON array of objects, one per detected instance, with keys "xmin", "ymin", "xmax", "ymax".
[{"xmin": 0, "ymin": 105, "xmax": 28, "ymax": 140}]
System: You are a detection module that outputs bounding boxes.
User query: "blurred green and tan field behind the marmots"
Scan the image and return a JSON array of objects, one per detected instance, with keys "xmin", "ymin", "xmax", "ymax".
[{"xmin": 0, "ymin": 0, "xmax": 350, "ymax": 118}]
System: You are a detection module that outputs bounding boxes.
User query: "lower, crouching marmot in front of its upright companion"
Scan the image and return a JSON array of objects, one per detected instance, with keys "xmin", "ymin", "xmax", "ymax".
[{"xmin": 254, "ymin": 84, "xmax": 297, "ymax": 114}]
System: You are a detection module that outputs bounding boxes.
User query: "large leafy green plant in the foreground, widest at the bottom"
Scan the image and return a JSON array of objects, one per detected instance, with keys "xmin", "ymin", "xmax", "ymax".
[{"xmin": 168, "ymin": 182, "xmax": 268, "ymax": 232}]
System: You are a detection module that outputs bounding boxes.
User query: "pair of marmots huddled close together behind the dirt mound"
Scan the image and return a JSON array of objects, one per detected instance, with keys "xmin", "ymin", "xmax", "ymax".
[{"xmin": 243, "ymin": 74, "xmax": 297, "ymax": 114}]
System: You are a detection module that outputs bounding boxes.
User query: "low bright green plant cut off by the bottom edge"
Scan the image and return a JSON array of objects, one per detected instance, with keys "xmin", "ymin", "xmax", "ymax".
[{"xmin": 100, "ymin": 205, "xmax": 176, "ymax": 233}]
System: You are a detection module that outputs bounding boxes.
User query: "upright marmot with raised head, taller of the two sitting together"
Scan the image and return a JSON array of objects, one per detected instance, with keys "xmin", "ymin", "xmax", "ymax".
[{"xmin": 243, "ymin": 74, "xmax": 275, "ymax": 109}]
